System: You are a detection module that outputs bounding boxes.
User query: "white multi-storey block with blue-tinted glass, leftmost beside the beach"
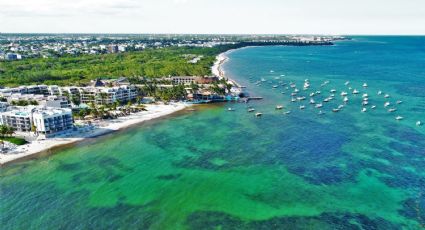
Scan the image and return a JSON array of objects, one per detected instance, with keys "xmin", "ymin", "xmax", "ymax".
[{"xmin": 0, "ymin": 106, "xmax": 74, "ymax": 135}]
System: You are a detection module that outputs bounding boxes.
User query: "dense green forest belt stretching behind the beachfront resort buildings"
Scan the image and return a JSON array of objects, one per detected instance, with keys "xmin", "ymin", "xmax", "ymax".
[{"xmin": 0, "ymin": 46, "xmax": 233, "ymax": 86}]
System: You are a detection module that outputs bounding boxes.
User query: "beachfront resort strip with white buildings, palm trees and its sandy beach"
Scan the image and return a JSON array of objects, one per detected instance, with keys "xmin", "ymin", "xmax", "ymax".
[{"xmin": 0, "ymin": 73, "xmax": 242, "ymax": 164}]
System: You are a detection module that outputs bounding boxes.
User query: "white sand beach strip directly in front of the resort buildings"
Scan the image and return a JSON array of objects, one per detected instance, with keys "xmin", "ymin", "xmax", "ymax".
[{"xmin": 0, "ymin": 103, "xmax": 190, "ymax": 165}]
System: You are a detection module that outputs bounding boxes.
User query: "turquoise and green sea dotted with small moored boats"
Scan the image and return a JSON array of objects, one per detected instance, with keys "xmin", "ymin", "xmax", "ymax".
[{"xmin": 0, "ymin": 37, "xmax": 425, "ymax": 229}]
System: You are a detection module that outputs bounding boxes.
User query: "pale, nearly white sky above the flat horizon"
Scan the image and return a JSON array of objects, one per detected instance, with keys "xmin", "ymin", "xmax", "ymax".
[{"xmin": 0, "ymin": 0, "xmax": 425, "ymax": 35}]
